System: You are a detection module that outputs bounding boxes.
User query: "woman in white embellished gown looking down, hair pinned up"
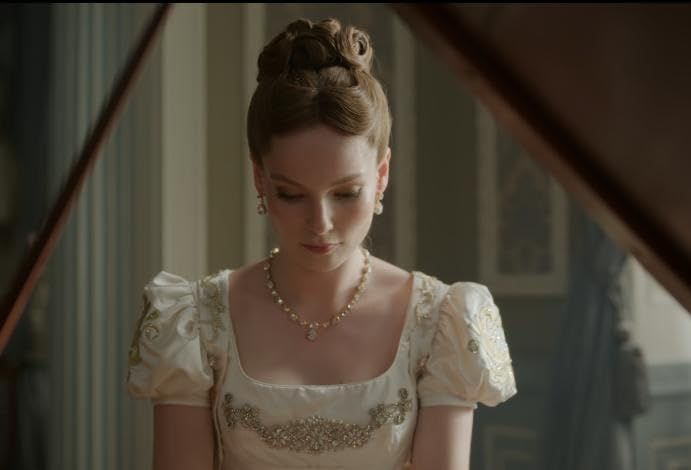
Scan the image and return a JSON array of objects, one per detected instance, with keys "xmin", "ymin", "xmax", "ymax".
[{"xmin": 128, "ymin": 19, "xmax": 516, "ymax": 470}]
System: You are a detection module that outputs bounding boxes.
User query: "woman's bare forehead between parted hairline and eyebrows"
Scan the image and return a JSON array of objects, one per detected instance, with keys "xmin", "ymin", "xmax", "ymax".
[{"xmin": 263, "ymin": 125, "xmax": 376, "ymax": 179}]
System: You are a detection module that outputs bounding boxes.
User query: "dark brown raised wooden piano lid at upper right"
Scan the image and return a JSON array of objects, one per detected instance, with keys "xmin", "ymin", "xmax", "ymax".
[{"xmin": 394, "ymin": 4, "xmax": 691, "ymax": 311}]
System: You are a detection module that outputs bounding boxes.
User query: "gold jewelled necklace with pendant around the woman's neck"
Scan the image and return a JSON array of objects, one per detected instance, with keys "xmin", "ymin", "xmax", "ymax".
[{"xmin": 264, "ymin": 248, "xmax": 372, "ymax": 341}]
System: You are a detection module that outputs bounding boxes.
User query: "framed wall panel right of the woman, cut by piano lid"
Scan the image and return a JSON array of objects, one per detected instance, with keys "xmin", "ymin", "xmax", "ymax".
[{"xmin": 475, "ymin": 104, "xmax": 568, "ymax": 295}]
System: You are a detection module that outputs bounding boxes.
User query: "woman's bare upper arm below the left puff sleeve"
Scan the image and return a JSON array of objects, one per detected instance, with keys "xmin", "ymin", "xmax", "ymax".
[{"xmin": 154, "ymin": 405, "xmax": 214, "ymax": 470}]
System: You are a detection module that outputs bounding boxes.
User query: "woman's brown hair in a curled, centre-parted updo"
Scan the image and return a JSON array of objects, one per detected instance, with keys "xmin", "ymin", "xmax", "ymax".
[{"xmin": 247, "ymin": 19, "xmax": 391, "ymax": 163}]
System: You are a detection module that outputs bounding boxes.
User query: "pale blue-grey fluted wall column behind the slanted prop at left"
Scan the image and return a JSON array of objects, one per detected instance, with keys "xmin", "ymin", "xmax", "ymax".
[{"xmin": 44, "ymin": 4, "xmax": 163, "ymax": 469}]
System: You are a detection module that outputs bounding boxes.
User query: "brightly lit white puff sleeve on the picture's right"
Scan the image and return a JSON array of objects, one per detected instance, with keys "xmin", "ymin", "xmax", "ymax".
[{"xmin": 418, "ymin": 282, "xmax": 516, "ymax": 408}]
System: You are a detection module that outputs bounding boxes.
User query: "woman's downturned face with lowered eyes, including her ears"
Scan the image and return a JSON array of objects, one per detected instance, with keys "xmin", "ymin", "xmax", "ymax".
[{"xmin": 254, "ymin": 125, "xmax": 390, "ymax": 272}]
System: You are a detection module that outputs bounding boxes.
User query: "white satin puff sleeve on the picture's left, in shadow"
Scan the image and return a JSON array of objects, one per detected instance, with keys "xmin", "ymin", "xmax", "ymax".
[{"xmin": 127, "ymin": 271, "xmax": 213, "ymax": 406}]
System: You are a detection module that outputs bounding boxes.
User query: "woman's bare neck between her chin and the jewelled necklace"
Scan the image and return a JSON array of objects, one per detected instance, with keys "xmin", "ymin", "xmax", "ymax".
[{"xmin": 271, "ymin": 249, "xmax": 365, "ymax": 321}]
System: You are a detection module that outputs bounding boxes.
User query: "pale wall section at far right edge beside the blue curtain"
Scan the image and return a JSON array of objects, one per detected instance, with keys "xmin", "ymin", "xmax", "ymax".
[{"xmin": 622, "ymin": 258, "xmax": 691, "ymax": 469}]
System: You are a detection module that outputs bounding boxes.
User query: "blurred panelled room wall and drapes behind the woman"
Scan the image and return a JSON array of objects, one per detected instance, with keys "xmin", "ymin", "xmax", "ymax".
[{"xmin": 0, "ymin": 4, "xmax": 691, "ymax": 470}]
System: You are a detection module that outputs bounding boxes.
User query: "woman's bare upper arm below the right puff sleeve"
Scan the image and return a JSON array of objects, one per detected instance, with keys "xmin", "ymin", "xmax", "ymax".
[{"xmin": 412, "ymin": 406, "xmax": 473, "ymax": 470}]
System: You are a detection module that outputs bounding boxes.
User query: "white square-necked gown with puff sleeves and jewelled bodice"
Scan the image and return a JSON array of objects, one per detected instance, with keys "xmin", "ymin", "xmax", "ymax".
[{"xmin": 127, "ymin": 270, "xmax": 516, "ymax": 470}]
